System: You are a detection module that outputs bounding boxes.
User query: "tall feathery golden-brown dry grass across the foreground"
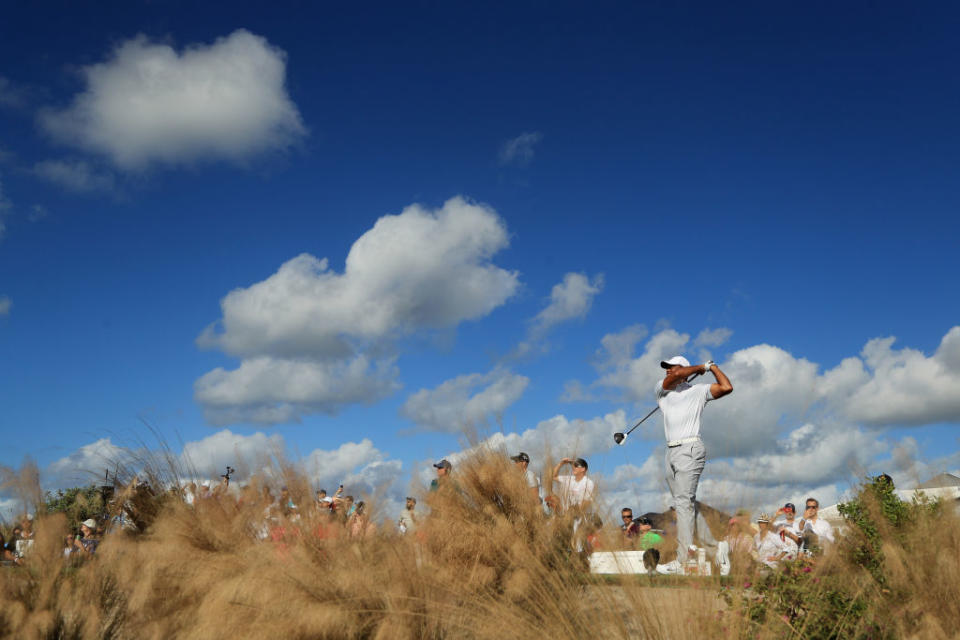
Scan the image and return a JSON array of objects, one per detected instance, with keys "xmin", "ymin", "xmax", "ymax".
[{"xmin": 0, "ymin": 451, "xmax": 960, "ymax": 640}]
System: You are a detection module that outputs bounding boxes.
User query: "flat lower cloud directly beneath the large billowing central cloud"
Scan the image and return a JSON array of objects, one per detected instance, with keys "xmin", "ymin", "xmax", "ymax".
[{"xmin": 194, "ymin": 355, "xmax": 398, "ymax": 425}]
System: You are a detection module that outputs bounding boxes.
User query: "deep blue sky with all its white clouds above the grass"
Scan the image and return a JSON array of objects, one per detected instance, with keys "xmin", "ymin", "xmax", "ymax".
[{"xmin": 0, "ymin": 3, "xmax": 960, "ymax": 511}]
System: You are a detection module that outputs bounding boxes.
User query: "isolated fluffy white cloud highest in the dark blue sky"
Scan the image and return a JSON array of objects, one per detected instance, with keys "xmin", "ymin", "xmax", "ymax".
[{"xmin": 40, "ymin": 29, "xmax": 306, "ymax": 170}]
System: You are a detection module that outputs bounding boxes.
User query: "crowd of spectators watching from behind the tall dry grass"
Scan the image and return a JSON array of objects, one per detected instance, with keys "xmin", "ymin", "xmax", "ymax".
[{"xmin": 0, "ymin": 451, "xmax": 834, "ymax": 575}]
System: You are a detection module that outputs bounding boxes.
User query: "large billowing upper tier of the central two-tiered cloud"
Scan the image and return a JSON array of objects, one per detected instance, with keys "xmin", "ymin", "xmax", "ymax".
[{"xmin": 199, "ymin": 197, "xmax": 519, "ymax": 357}]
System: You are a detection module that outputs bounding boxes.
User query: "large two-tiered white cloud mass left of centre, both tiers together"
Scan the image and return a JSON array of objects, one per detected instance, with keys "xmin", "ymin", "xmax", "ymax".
[{"xmin": 194, "ymin": 197, "xmax": 519, "ymax": 424}]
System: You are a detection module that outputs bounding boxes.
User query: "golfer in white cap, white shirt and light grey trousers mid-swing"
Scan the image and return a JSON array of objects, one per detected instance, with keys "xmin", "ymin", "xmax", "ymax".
[{"xmin": 656, "ymin": 356, "xmax": 733, "ymax": 563}]
